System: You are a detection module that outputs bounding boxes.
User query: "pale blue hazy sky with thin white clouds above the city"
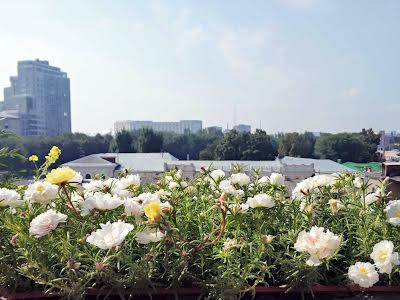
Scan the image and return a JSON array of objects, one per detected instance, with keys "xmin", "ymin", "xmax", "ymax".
[{"xmin": 0, "ymin": 0, "xmax": 400, "ymax": 133}]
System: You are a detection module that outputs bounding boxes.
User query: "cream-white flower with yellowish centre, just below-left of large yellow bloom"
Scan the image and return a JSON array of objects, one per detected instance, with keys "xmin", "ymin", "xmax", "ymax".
[{"xmin": 25, "ymin": 181, "xmax": 58, "ymax": 204}]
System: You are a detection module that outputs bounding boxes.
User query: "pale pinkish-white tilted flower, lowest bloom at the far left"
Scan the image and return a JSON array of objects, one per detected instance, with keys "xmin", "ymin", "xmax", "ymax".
[{"xmin": 29, "ymin": 209, "xmax": 67, "ymax": 238}]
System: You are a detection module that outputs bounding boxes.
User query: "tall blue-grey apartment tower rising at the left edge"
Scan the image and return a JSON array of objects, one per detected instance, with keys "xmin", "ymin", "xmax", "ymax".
[{"xmin": 1, "ymin": 59, "xmax": 71, "ymax": 136}]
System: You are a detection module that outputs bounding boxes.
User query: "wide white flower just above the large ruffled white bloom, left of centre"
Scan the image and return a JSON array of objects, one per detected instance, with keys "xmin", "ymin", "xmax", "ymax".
[{"xmin": 81, "ymin": 192, "xmax": 124, "ymax": 216}]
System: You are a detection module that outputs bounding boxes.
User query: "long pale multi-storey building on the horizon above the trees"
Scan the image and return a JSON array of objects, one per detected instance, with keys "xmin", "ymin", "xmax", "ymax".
[{"xmin": 114, "ymin": 120, "xmax": 203, "ymax": 134}]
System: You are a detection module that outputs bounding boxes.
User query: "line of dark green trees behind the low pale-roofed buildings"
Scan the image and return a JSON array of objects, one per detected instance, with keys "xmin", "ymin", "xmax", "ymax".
[{"xmin": 0, "ymin": 128, "xmax": 380, "ymax": 175}]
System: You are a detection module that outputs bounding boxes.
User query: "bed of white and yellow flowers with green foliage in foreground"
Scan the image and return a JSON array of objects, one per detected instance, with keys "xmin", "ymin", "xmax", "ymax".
[{"xmin": 0, "ymin": 149, "xmax": 400, "ymax": 299}]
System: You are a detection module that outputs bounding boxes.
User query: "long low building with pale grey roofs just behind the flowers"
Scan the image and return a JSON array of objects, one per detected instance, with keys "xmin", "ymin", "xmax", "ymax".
[{"xmin": 63, "ymin": 153, "xmax": 354, "ymax": 182}]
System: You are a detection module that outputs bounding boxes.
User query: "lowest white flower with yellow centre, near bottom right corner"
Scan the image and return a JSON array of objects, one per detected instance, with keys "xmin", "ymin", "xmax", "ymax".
[{"xmin": 347, "ymin": 262, "xmax": 379, "ymax": 288}]
